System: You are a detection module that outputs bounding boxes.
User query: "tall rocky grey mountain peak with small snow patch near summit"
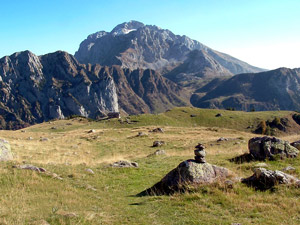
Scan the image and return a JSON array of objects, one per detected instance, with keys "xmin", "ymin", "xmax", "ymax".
[{"xmin": 75, "ymin": 21, "xmax": 262, "ymax": 80}]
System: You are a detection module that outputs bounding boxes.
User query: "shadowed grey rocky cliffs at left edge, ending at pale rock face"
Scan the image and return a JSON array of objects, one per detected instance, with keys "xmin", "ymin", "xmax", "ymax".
[{"xmin": 0, "ymin": 51, "xmax": 119, "ymax": 129}]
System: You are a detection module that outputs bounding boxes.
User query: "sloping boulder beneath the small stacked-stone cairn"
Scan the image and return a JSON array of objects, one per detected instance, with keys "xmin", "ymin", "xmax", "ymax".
[{"xmin": 140, "ymin": 159, "xmax": 229, "ymax": 195}]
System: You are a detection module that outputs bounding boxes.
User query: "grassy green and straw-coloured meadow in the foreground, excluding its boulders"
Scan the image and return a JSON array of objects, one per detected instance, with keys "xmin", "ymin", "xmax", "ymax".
[{"xmin": 0, "ymin": 108, "xmax": 300, "ymax": 225}]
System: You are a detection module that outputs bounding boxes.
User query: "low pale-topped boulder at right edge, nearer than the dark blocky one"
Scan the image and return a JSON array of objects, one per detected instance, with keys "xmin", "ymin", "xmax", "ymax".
[{"xmin": 242, "ymin": 168, "xmax": 300, "ymax": 190}]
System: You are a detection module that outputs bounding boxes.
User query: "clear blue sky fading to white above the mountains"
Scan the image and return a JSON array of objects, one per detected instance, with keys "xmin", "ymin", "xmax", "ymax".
[{"xmin": 0, "ymin": 0, "xmax": 300, "ymax": 69}]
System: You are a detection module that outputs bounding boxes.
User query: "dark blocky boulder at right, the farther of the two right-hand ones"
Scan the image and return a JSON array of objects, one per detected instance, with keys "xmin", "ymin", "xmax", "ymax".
[{"xmin": 248, "ymin": 136, "xmax": 299, "ymax": 160}]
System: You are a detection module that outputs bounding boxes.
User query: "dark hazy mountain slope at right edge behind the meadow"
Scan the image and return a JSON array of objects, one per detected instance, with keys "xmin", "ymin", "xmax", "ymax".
[{"xmin": 191, "ymin": 68, "xmax": 300, "ymax": 111}]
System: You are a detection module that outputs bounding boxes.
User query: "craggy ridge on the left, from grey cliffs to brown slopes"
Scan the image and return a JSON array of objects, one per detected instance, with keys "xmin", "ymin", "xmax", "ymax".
[{"xmin": 0, "ymin": 51, "xmax": 189, "ymax": 129}]
